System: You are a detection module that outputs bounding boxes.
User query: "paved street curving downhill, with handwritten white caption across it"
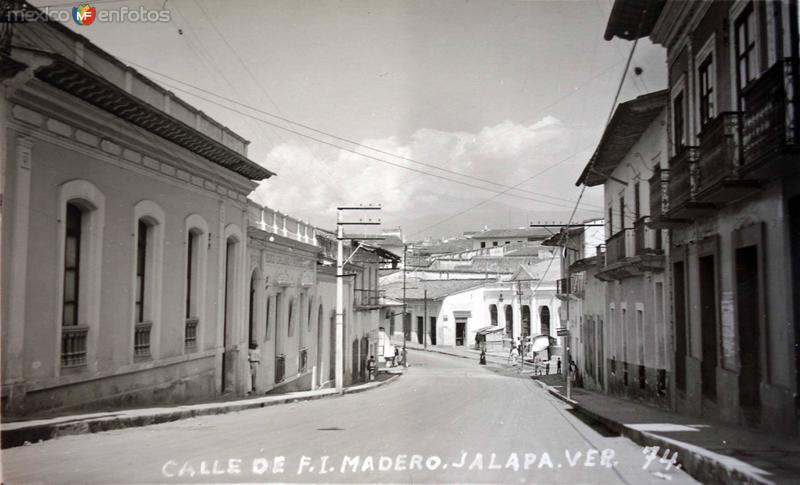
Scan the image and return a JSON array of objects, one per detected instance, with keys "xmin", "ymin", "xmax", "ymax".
[{"xmin": 3, "ymin": 352, "xmax": 691, "ymax": 484}]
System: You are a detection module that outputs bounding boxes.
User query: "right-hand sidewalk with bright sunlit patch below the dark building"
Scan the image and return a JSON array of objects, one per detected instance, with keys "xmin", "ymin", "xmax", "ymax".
[{"xmin": 535, "ymin": 375, "xmax": 800, "ymax": 483}]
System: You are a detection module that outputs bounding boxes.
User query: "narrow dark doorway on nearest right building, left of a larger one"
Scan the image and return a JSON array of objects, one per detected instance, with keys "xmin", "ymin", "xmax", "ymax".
[{"xmin": 698, "ymin": 255, "xmax": 717, "ymax": 401}]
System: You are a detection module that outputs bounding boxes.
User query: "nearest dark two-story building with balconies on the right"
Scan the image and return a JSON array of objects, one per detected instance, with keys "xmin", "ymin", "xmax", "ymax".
[{"xmin": 605, "ymin": 0, "xmax": 800, "ymax": 432}]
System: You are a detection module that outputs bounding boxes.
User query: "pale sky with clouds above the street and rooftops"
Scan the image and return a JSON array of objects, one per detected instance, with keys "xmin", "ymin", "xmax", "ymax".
[{"xmin": 33, "ymin": 0, "xmax": 666, "ymax": 239}]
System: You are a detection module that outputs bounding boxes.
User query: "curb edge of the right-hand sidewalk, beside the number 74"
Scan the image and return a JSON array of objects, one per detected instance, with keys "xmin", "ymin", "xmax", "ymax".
[{"xmin": 536, "ymin": 380, "xmax": 774, "ymax": 485}]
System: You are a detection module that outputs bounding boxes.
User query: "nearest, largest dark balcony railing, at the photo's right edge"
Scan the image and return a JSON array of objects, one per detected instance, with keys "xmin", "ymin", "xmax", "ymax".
[{"xmin": 742, "ymin": 59, "xmax": 800, "ymax": 167}]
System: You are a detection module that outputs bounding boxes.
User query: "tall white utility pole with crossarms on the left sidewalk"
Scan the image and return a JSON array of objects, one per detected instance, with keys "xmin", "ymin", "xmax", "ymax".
[{"xmin": 336, "ymin": 204, "xmax": 382, "ymax": 394}]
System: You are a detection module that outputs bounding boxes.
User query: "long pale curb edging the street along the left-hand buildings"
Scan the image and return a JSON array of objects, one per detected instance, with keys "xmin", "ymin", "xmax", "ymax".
[{"xmin": 0, "ymin": 374, "xmax": 402, "ymax": 449}]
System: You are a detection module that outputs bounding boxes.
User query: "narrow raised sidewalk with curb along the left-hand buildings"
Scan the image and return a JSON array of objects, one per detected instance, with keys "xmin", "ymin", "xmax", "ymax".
[{"xmin": 0, "ymin": 371, "xmax": 402, "ymax": 448}]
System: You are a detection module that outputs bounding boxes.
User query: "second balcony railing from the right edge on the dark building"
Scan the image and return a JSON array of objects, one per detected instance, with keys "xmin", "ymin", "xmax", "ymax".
[{"xmin": 697, "ymin": 112, "xmax": 742, "ymax": 192}]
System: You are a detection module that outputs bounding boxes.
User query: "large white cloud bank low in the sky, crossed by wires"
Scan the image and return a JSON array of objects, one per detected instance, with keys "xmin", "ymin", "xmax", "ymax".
[{"xmin": 251, "ymin": 116, "xmax": 600, "ymax": 238}]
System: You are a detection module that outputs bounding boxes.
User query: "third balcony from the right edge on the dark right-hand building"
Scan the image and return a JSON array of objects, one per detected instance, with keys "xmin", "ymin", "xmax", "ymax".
[{"xmin": 667, "ymin": 147, "xmax": 715, "ymax": 217}]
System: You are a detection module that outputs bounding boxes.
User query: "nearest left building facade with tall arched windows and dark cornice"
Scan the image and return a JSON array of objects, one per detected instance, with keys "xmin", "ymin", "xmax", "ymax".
[{"xmin": 0, "ymin": 17, "xmax": 271, "ymax": 415}]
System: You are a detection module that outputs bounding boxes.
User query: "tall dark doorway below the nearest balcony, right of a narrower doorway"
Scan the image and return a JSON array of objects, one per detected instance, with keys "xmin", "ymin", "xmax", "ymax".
[{"xmin": 736, "ymin": 246, "xmax": 761, "ymax": 416}]
